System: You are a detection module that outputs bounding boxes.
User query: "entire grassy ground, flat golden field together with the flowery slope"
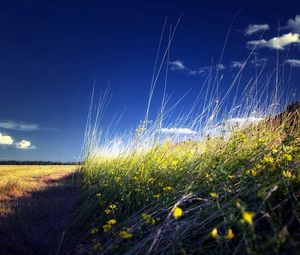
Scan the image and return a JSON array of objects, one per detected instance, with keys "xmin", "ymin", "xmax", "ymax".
[{"xmin": 0, "ymin": 109, "xmax": 300, "ymax": 255}]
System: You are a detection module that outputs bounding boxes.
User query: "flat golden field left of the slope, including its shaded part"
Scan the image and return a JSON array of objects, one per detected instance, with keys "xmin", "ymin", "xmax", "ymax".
[{"xmin": 0, "ymin": 165, "xmax": 78, "ymax": 254}]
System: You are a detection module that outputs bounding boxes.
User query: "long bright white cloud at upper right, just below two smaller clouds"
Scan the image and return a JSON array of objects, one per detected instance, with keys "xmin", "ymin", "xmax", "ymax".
[{"xmin": 247, "ymin": 33, "xmax": 300, "ymax": 50}]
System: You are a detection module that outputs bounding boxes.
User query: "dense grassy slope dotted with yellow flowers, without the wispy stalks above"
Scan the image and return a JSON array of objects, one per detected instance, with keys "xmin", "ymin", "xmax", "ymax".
[{"xmin": 64, "ymin": 104, "xmax": 300, "ymax": 254}]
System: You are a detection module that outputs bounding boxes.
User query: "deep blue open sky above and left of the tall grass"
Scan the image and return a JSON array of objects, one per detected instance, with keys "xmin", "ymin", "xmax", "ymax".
[{"xmin": 0, "ymin": 0, "xmax": 300, "ymax": 161}]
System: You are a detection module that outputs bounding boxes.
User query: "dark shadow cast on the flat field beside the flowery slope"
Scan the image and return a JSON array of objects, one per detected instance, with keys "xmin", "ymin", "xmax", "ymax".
[{"xmin": 0, "ymin": 173, "xmax": 81, "ymax": 255}]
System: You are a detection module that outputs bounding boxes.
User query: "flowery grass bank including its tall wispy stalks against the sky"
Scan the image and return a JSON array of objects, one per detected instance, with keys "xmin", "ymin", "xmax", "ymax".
[{"xmin": 71, "ymin": 20, "xmax": 300, "ymax": 254}]
